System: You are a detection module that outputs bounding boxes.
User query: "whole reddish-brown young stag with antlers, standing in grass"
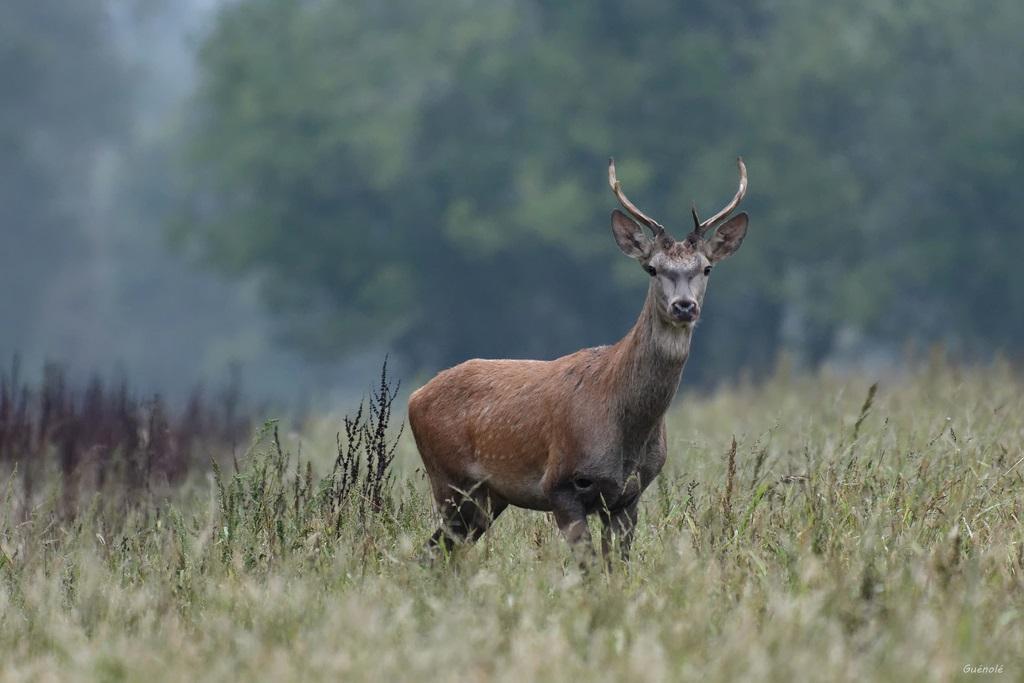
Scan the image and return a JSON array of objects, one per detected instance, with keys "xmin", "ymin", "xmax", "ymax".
[{"xmin": 408, "ymin": 158, "xmax": 748, "ymax": 568}]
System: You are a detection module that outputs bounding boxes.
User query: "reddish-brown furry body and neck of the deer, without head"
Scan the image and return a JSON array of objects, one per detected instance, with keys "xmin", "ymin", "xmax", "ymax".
[{"xmin": 409, "ymin": 278, "xmax": 691, "ymax": 561}]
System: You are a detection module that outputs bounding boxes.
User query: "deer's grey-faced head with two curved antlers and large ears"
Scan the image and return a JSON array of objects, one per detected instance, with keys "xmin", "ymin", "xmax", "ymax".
[{"xmin": 608, "ymin": 159, "xmax": 748, "ymax": 327}]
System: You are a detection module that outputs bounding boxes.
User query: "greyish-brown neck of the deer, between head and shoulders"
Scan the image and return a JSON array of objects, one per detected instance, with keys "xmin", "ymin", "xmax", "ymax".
[{"xmin": 613, "ymin": 284, "xmax": 693, "ymax": 440}]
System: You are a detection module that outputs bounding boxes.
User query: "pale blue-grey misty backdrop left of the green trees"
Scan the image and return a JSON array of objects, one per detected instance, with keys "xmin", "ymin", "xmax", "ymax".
[{"xmin": 0, "ymin": 0, "xmax": 348, "ymax": 402}]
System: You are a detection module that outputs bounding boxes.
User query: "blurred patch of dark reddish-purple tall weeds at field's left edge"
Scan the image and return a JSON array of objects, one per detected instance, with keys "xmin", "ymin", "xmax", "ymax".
[{"xmin": 0, "ymin": 359, "xmax": 252, "ymax": 518}]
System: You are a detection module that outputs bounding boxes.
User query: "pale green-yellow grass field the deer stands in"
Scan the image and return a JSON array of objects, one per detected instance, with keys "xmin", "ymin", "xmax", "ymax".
[{"xmin": 0, "ymin": 361, "xmax": 1024, "ymax": 683}]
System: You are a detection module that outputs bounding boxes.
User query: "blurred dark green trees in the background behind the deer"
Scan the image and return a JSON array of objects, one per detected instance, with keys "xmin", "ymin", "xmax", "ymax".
[{"xmin": 18, "ymin": 0, "xmax": 1024, "ymax": 381}]
